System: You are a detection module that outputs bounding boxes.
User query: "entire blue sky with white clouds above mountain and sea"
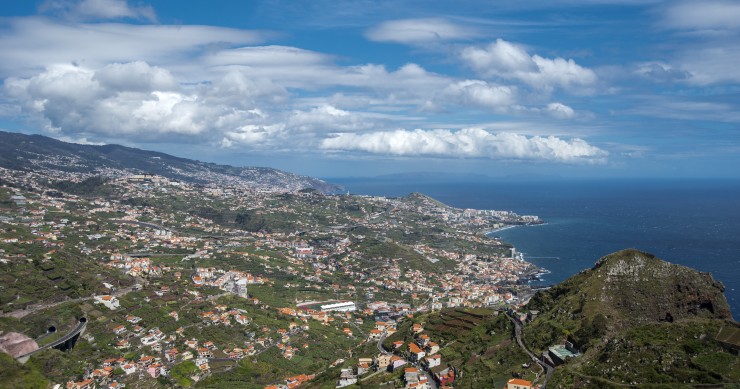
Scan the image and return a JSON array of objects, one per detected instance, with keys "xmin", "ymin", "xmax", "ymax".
[{"xmin": 0, "ymin": 0, "xmax": 740, "ymax": 178}]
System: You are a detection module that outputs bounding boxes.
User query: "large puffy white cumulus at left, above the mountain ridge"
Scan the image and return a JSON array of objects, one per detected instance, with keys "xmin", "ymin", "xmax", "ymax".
[{"xmin": 4, "ymin": 62, "xmax": 208, "ymax": 138}]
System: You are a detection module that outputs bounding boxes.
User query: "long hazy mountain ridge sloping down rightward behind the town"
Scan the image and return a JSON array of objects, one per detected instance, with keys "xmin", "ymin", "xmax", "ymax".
[{"xmin": 0, "ymin": 131, "xmax": 342, "ymax": 193}]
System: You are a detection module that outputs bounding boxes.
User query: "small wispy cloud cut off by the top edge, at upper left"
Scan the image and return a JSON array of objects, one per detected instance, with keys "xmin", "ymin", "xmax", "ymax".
[{"xmin": 39, "ymin": 0, "xmax": 157, "ymax": 22}]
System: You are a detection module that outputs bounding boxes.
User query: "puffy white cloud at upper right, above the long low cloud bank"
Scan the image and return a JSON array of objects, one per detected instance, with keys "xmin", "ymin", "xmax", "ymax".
[{"xmin": 461, "ymin": 39, "xmax": 597, "ymax": 89}]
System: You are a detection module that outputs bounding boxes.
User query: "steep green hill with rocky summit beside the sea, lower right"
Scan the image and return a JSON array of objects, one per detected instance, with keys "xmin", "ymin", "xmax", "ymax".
[{"xmin": 523, "ymin": 250, "xmax": 740, "ymax": 387}]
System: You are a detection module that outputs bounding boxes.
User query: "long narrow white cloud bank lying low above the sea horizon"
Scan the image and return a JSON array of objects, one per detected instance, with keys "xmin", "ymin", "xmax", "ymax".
[{"xmin": 321, "ymin": 128, "xmax": 608, "ymax": 163}]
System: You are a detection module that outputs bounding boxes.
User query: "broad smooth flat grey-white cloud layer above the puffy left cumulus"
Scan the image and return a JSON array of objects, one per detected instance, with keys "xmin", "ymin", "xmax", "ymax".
[{"xmin": 0, "ymin": 17, "xmax": 265, "ymax": 77}]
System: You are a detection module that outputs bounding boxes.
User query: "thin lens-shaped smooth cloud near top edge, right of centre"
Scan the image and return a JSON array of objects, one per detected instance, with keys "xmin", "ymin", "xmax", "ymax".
[{"xmin": 365, "ymin": 18, "xmax": 478, "ymax": 44}]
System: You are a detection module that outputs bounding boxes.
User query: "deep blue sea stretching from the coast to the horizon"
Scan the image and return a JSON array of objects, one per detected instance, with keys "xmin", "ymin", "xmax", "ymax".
[{"xmin": 333, "ymin": 178, "xmax": 740, "ymax": 317}]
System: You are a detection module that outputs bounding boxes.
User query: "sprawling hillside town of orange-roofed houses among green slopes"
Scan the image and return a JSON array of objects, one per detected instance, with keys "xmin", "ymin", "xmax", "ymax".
[{"xmin": 0, "ymin": 165, "xmax": 542, "ymax": 389}]
